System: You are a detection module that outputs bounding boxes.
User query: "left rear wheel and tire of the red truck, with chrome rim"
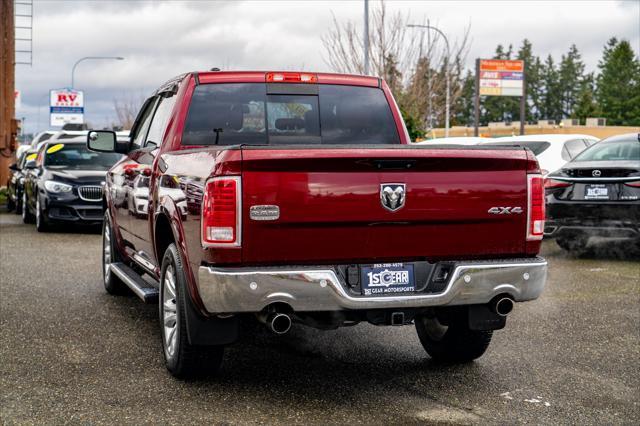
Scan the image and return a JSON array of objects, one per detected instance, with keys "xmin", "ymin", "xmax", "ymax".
[{"xmin": 158, "ymin": 244, "xmax": 224, "ymax": 379}]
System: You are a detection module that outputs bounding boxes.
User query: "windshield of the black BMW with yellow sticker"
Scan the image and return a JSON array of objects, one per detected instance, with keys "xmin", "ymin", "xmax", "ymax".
[{"xmin": 44, "ymin": 143, "xmax": 122, "ymax": 170}]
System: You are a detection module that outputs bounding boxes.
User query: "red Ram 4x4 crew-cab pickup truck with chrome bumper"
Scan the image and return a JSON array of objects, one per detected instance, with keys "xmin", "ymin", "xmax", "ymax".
[{"xmin": 87, "ymin": 71, "xmax": 547, "ymax": 377}]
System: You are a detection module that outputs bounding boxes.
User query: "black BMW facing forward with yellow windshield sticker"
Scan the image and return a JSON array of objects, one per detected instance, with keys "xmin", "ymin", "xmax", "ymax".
[{"xmin": 22, "ymin": 137, "xmax": 122, "ymax": 232}]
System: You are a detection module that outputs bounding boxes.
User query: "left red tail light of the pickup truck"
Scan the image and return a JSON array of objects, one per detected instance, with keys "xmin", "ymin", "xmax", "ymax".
[{"xmin": 201, "ymin": 176, "xmax": 242, "ymax": 247}]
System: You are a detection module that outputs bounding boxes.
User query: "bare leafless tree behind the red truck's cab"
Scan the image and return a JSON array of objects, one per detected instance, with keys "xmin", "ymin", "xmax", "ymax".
[{"xmin": 322, "ymin": 2, "xmax": 470, "ymax": 135}]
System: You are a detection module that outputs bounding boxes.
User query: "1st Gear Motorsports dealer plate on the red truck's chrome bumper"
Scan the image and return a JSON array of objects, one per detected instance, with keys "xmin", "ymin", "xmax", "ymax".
[{"xmin": 360, "ymin": 263, "xmax": 416, "ymax": 296}]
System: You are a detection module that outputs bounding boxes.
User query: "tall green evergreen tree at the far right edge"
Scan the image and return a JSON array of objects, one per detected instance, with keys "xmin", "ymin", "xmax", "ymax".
[{"xmin": 597, "ymin": 38, "xmax": 640, "ymax": 126}]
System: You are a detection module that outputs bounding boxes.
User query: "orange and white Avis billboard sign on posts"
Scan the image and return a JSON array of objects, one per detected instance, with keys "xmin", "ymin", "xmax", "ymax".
[{"xmin": 479, "ymin": 59, "xmax": 524, "ymax": 96}]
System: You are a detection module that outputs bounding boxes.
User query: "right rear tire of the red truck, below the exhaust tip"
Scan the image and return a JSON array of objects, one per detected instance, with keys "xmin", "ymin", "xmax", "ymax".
[{"xmin": 415, "ymin": 317, "xmax": 493, "ymax": 364}]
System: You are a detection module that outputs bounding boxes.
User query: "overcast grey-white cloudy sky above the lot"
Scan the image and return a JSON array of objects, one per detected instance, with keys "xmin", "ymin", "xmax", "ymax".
[{"xmin": 16, "ymin": 0, "xmax": 640, "ymax": 132}]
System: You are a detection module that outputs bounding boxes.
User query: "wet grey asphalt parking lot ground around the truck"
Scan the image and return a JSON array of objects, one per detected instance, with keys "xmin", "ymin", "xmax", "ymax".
[{"xmin": 0, "ymin": 213, "xmax": 640, "ymax": 424}]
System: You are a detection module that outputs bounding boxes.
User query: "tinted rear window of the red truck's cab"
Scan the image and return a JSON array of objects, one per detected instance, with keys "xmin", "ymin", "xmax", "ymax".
[{"xmin": 182, "ymin": 83, "xmax": 400, "ymax": 145}]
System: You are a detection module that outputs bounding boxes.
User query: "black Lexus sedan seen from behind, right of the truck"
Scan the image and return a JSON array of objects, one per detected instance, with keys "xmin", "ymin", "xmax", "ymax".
[{"xmin": 545, "ymin": 133, "xmax": 640, "ymax": 253}]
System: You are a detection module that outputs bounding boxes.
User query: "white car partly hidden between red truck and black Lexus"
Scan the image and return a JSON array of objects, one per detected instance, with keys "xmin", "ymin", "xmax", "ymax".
[{"xmin": 483, "ymin": 135, "xmax": 598, "ymax": 175}]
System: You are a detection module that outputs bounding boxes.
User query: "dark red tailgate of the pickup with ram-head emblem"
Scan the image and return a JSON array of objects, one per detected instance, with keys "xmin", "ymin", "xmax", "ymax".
[{"xmin": 242, "ymin": 146, "xmax": 527, "ymax": 265}]
